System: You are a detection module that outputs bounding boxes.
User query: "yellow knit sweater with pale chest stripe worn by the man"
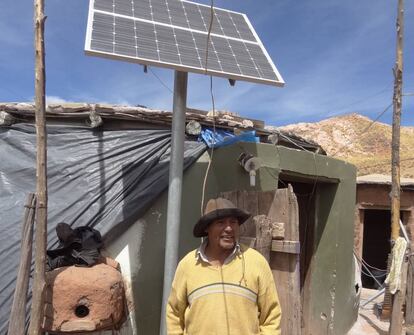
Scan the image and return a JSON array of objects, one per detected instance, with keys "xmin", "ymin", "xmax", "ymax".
[{"xmin": 167, "ymin": 246, "xmax": 281, "ymax": 335}]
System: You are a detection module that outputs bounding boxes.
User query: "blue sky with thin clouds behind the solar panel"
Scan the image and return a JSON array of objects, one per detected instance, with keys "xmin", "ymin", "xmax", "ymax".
[{"xmin": 0, "ymin": 0, "xmax": 414, "ymax": 126}]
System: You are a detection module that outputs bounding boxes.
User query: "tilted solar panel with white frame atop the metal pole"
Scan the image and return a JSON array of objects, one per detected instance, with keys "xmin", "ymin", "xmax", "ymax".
[{"xmin": 85, "ymin": 0, "xmax": 284, "ymax": 86}]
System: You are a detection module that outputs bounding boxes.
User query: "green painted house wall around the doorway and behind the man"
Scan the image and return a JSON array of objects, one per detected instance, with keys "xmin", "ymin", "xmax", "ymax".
[{"xmin": 108, "ymin": 143, "xmax": 357, "ymax": 335}]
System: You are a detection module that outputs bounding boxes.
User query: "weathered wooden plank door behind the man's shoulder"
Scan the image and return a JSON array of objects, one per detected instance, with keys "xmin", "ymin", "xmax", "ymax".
[{"xmin": 222, "ymin": 185, "xmax": 302, "ymax": 335}]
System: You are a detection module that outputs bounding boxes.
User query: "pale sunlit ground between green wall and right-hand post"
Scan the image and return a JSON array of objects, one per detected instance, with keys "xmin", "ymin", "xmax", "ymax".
[{"xmin": 347, "ymin": 288, "xmax": 405, "ymax": 335}]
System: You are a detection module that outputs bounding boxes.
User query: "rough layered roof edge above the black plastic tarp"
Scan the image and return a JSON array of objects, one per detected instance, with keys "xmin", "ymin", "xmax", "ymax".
[{"xmin": 0, "ymin": 102, "xmax": 326, "ymax": 155}]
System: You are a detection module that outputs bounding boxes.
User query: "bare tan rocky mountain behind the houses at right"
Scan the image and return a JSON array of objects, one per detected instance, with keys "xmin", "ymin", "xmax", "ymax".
[{"xmin": 266, "ymin": 114, "xmax": 414, "ymax": 178}]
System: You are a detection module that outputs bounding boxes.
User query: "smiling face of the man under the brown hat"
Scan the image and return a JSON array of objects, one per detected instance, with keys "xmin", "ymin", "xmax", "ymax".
[{"xmin": 206, "ymin": 216, "xmax": 239, "ymax": 250}]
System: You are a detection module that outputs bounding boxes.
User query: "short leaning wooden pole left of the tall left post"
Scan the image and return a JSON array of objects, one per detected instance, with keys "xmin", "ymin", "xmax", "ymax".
[{"xmin": 7, "ymin": 193, "xmax": 36, "ymax": 335}]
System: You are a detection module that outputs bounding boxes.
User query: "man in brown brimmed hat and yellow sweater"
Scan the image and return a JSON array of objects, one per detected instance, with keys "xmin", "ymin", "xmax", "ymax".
[{"xmin": 167, "ymin": 198, "xmax": 281, "ymax": 335}]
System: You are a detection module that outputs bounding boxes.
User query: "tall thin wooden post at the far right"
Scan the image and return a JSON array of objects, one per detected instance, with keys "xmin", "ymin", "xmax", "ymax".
[{"xmin": 389, "ymin": 0, "xmax": 407, "ymax": 335}]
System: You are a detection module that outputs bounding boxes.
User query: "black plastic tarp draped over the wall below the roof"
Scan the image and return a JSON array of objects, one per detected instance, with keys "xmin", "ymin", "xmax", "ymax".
[{"xmin": 0, "ymin": 124, "xmax": 206, "ymax": 334}]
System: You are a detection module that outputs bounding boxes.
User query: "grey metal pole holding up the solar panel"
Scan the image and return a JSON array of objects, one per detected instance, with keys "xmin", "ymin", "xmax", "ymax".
[{"xmin": 160, "ymin": 71, "xmax": 188, "ymax": 335}]
